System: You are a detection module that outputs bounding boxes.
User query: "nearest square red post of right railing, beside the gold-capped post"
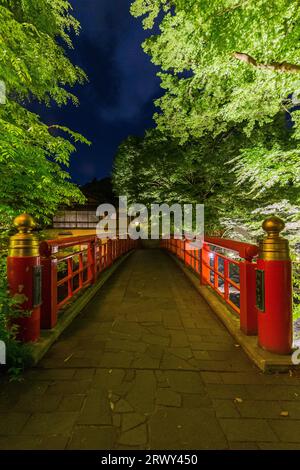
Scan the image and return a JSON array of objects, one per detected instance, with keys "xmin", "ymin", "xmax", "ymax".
[{"xmin": 240, "ymin": 260, "xmax": 257, "ymax": 336}]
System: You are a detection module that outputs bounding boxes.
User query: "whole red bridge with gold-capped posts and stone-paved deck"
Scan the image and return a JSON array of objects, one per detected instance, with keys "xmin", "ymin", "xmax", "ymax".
[{"xmin": 0, "ymin": 212, "xmax": 300, "ymax": 449}]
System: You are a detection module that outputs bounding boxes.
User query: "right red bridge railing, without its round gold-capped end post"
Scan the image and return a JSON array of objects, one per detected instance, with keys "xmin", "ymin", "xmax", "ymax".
[{"xmin": 161, "ymin": 237, "xmax": 258, "ymax": 335}]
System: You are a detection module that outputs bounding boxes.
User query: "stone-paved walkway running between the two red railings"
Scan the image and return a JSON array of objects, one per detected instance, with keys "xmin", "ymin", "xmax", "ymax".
[{"xmin": 0, "ymin": 250, "xmax": 300, "ymax": 450}]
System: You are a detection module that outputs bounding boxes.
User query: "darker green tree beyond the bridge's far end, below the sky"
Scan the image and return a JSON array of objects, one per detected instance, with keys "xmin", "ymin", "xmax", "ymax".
[{"xmin": 113, "ymin": 130, "xmax": 241, "ymax": 229}]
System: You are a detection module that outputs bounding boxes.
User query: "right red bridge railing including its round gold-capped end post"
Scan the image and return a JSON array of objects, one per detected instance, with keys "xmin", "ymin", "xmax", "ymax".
[{"xmin": 161, "ymin": 217, "xmax": 293, "ymax": 354}]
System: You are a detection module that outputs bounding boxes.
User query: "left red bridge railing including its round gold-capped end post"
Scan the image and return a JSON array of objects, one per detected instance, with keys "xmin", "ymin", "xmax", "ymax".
[{"xmin": 7, "ymin": 214, "xmax": 137, "ymax": 342}]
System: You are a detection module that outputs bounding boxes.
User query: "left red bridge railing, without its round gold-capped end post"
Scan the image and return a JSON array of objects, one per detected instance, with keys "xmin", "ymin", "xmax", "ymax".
[{"xmin": 40, "ymin": 235, "xmax": 137, "ymax": 329}]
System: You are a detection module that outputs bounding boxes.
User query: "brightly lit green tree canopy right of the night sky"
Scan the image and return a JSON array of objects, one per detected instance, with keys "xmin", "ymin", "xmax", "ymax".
[{"xmin": 112, "ymin": 0, "xmax": 300, "ymax": 239}]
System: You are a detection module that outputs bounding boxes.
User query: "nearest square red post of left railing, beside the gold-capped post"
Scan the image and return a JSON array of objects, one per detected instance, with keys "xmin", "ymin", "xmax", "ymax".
[{"xmin": 40, "ymin": 242, "xmax": 58, "ymax": 330}]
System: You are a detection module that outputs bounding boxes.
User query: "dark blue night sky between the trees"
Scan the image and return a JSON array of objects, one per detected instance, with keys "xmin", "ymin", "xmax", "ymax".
[{"xmin": 41, "ymin": 0, "xmax": 161, "ymax": 184}]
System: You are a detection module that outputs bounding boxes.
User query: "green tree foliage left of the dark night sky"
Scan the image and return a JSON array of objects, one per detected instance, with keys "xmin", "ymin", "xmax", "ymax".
[{"xmin": 0, "ymin": 0, "xmax": 88, "ymax": 228}]
